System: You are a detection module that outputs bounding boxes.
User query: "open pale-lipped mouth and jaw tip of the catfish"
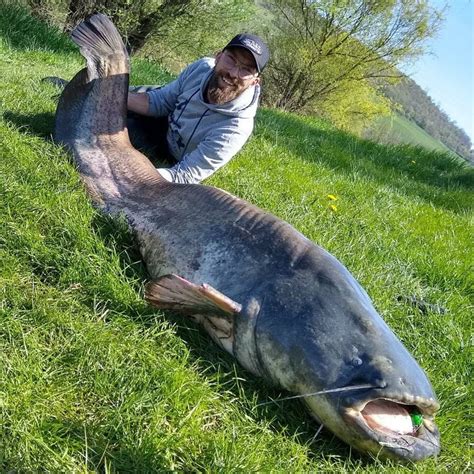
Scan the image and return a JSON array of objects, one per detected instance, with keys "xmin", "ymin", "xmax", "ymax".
[{"xmin": 344, "ymin": 397, "xmax": 440, "ymax": 461}]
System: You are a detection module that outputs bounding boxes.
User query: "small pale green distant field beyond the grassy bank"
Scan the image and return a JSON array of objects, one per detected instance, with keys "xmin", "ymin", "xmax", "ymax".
[{"xmin": 373, "ymin": 113, "xmax": 452, "ymax": 153}]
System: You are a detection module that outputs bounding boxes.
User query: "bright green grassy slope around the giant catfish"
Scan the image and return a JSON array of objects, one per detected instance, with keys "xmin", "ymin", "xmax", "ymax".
[{"xmin": 0, "ymin": 4, "xmax": 474, "ymax": 472}]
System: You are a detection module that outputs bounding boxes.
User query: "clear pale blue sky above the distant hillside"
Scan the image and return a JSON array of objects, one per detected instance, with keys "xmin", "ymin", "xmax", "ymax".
[{"xmin": 405, "ymin": 0, "xmax": 474, "ymax": 146}]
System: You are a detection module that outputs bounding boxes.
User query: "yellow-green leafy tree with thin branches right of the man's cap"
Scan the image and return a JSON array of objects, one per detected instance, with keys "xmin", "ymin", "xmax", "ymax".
[{"xmin": 264, "ymin": 0, "xmax": 441, "ymax": 115}]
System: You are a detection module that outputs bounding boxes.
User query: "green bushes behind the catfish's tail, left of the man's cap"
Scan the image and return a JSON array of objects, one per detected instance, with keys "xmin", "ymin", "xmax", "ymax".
[{"xmin": 23, "ymin": 0, "xmax": 255, "ymax": 71}]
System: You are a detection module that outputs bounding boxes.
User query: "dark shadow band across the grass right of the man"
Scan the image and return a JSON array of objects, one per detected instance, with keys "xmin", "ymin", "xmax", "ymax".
[{"xmin": 258, "ymin": 109, "xmax": 474, "ymax": 212}]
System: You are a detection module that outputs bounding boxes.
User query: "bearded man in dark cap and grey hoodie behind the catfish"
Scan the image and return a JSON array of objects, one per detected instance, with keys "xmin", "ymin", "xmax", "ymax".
[{"xmin": 128, "ymin": 34, "xmax": 269, "ymax": 183}]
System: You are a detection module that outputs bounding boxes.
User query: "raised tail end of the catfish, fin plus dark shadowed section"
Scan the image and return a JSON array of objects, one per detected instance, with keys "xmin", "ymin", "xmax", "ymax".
[{"xmin": 54, "ymin": 13, "xmax": 130, "ymax": 144}]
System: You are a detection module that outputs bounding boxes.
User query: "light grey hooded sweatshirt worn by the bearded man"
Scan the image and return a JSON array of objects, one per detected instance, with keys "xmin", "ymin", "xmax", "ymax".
[{"xmin": 148, "ymin": 58, "xmax": 260, "ymax": 183}]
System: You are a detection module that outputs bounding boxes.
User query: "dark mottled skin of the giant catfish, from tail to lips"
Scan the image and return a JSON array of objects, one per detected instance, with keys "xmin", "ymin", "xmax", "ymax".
[{"xmin": 55, "ymin": 14, "xmax": 440, "ymax": 461}]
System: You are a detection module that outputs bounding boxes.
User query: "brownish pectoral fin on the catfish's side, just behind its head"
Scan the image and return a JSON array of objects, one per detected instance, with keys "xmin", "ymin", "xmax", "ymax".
[{"xmin": 145, "ymin": 274, "xmax": 242, "ymax": 317}]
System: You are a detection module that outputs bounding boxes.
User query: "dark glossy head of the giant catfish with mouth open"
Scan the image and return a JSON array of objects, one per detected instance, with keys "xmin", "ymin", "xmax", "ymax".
[{"xmin": 255, "ymin": 247, "xmax": 440, "ymax": 461}]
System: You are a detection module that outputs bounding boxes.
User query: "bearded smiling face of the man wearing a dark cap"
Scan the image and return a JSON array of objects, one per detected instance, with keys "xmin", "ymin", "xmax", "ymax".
[{"xmin": 207, "ymin": 48, "xmax": 260, "ymax": 104}]
